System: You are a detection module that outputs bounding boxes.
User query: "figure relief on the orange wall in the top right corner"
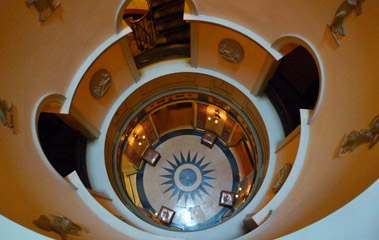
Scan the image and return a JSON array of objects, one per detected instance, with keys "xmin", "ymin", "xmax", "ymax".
[{"xmin": 328, "ymin": 0, "xmax": 364, "ymax": 46}]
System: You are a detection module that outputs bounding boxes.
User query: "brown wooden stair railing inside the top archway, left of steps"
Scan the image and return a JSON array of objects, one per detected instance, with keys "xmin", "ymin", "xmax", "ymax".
[{"xmin": 125, "ymin": 0, "xmax": 157, "ymax": 51}]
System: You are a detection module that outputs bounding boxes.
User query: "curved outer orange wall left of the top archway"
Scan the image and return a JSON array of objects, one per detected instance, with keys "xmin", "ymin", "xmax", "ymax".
[{"xmin": 0, "ymin": 0, "xmax": 144, "ymax": 239}]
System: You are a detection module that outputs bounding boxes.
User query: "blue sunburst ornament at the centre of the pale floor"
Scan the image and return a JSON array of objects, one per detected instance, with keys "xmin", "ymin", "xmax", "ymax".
[{"xmin": 160, "ymin": 151, "xmax": 215, "ymax": 205}]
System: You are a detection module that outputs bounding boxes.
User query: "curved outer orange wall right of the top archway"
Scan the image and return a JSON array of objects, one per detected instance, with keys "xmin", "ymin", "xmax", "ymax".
[{"xmin": 193, "ymin": 0, "xmax": 379, "ymax": 239}]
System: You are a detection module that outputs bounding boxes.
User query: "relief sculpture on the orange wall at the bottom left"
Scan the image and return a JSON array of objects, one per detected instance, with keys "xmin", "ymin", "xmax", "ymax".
[{"xmin": 33, "ymin": 214, "xmax": 88, "ymax": 240}]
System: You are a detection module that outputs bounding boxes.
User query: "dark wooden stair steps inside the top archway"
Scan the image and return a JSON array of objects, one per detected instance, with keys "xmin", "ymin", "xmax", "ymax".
[{"xmin": 124, "ymin": 0, "xmax": 190, "ymax": 69}]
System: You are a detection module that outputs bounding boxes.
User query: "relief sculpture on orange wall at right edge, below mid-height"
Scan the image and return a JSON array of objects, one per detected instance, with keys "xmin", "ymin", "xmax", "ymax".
[{"xmin": 338, "ymin": 115, "xmax": 379, "ymax": 157}]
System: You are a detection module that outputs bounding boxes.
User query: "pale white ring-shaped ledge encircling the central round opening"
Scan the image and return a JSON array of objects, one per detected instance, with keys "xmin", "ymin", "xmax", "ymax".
[{"xmin": 87, "ymin": 60, "xmax": 284, "ymax": 239}]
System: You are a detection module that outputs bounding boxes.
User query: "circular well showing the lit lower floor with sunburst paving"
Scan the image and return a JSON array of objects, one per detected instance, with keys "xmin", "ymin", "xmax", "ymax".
[{"xmin": 107, "ymin": 84, "xmax": 267, "ymax": 231}]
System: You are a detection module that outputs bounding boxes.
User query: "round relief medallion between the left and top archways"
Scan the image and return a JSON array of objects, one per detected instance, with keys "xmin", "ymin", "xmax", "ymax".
[{"xmin": 90, "ymin": 69, "xmax": 112, "ymax": 99}]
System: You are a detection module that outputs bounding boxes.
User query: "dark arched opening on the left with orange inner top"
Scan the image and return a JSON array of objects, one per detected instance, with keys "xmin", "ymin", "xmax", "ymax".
[{"xmin": 35, "ymin": 94, "xmax": 93, "ymax": 188}]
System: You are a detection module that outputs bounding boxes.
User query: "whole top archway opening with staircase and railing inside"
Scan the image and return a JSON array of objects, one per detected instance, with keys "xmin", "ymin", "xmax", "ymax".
[{"xmin": 119, "ymin": 0, "xmax": 190, "ymax": 69}]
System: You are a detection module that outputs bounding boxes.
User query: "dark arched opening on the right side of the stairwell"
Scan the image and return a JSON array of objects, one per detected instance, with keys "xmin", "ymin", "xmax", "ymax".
[{"xmin": 265, "ymin": 46, "xmax": 320, "ymax": 136}]
